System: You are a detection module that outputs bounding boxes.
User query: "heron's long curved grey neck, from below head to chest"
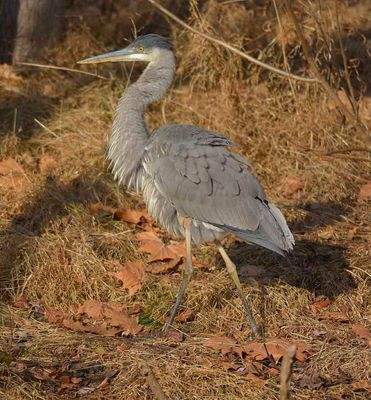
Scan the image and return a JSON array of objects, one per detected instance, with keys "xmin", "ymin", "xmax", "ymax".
[{"xmin": 107, "ymin": 50, "xmax": 175, "ymax": 190}]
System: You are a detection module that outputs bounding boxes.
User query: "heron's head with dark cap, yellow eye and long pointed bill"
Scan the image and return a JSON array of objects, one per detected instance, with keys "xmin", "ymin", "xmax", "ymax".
[{"xmin": 78, "ymin": 34, "xmax": 172, "ymax": 64}]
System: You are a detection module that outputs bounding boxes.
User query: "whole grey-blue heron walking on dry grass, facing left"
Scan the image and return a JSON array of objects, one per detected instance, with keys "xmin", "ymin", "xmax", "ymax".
[{"xmin": 79, "ymin": 34, "xmax": 294, "ymax": 337}]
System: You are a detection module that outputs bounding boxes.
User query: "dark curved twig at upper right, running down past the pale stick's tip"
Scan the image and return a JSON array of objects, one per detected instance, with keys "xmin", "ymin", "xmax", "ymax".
[{"xmin": 284, "ymin": 0, "xmax": 365, "ymax": 129}]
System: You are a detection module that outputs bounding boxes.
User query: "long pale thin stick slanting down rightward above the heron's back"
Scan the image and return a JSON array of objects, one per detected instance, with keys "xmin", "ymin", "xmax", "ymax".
[{"xmin": 148, "ymin": 0, "xmax": 317, "ymax": 82}]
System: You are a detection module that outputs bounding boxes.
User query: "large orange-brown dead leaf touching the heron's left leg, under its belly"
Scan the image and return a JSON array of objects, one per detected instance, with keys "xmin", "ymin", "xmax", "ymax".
[{"xmin": 136, "ymin": 232, "xmax": 186, "ymax": 261}]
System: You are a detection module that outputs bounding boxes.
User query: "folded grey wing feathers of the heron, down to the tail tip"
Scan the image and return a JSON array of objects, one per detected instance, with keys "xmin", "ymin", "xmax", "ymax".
[{"xmin": 147, "ymin": 125, "xmax": 293, "ymax": 252}]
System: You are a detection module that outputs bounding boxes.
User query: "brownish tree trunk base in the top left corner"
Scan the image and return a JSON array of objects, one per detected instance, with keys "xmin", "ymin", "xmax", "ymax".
[{"xmin": 11, "ymin": 0, "xmax": 64, "ymax": 64}]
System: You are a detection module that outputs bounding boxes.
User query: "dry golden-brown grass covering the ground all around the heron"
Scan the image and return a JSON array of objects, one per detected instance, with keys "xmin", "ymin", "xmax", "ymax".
[{"xmin": 0, "ymin": 1, "xmax": 371, "ymax": 400}]
